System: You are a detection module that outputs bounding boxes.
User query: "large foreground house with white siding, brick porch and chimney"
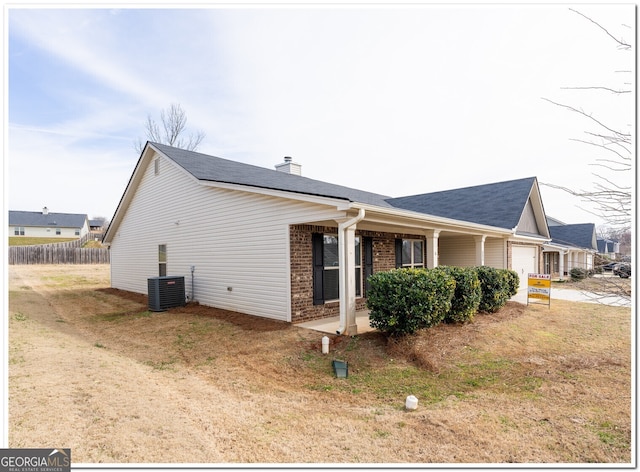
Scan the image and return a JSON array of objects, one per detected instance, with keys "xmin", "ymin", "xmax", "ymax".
[{"xmin": 104, "ymin": 143, "xmax": 551, "ymax": 334}]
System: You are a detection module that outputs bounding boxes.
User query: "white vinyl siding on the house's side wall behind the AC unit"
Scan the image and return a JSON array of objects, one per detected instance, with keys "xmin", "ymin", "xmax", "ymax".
[{"xmin": 111, "ymin": 153, "xmax": 343, "ymax": 321}]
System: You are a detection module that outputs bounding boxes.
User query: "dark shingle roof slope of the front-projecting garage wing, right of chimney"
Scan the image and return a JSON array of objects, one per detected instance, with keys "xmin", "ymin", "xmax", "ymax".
[{"xmin": 387, "ymin": 177, "xmax": 536, "ymax": 229}]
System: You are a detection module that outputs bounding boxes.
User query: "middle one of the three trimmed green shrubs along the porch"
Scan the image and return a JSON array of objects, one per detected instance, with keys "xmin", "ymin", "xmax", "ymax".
[{"xmin": 433, "ymin": 266, "xmax": 482, "ymax": 323}]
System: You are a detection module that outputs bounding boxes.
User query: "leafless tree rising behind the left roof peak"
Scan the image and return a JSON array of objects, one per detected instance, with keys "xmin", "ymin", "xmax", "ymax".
[{"xmin": 135, "ymin": 103, "xmax": 205, "ymax": 153}]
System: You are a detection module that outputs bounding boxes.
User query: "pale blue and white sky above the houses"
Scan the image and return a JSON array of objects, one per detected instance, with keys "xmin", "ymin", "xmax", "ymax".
[{"xmin": 4, "ymin": 4, "xmax": 635, "ymax": 225}]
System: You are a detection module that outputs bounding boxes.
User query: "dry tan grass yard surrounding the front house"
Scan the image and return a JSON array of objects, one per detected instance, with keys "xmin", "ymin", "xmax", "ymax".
[{"xmin": 7, "ymin": 265, "xmax": 632, "ymax": 465}]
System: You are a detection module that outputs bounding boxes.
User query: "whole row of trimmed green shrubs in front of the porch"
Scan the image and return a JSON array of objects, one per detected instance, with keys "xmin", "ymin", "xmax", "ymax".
[{"xmin": 367, "ymin": 266, "xmax": 520, "ymax": 336}]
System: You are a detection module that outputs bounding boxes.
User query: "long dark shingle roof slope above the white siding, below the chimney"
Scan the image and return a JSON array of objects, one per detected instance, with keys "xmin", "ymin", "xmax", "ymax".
[{"xmin": 155, "ymin": 143, "xmax": 396, "ymax": 207}]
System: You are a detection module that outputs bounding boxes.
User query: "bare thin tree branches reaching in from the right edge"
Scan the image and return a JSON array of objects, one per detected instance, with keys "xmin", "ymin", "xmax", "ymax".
[{"xmin": 542, "ymin": 8, "xmax": 633, "ymax": 229}]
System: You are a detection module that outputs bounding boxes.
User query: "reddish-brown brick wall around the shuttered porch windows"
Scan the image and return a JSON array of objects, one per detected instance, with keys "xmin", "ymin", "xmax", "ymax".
[{"xmin": 289, "ymin": 225, "xmax": 426, "ymax": 323}]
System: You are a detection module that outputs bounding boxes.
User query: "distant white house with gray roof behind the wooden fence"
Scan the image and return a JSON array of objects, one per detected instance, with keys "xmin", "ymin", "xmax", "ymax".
[{"xmin": 9, "ymin": 207, "xmax": 89, "ymax": 238}]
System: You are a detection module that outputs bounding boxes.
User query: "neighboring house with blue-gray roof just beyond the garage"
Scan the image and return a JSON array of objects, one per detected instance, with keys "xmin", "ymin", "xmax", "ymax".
[{"xmin": 543, "ymin": 217, "xmax": 598, "ymax": 280}]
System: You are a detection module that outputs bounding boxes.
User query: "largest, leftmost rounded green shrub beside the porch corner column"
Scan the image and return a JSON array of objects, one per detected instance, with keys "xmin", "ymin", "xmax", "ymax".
[{"xmin": 367, "ymin": 269, "xmax": 456, "ymax": 336}]
